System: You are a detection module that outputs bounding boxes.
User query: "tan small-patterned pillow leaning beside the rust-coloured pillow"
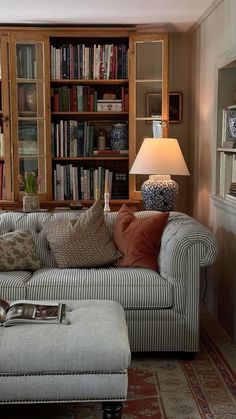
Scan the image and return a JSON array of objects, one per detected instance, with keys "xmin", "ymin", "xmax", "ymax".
[{"xmin": 43, "ymin": 201, "xmax": 120, "ymax": 268}]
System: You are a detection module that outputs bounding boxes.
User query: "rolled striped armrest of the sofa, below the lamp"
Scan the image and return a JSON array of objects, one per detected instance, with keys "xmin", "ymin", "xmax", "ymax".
[{"xmin": 159, "ymin": 212, "xmax": 218, "ymax": 283}]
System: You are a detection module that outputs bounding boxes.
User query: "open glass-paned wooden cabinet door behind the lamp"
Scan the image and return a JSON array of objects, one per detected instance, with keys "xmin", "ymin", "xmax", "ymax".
[{"xmin": 129, "ymin": 35, "xmax": 168, "ymax": 199}]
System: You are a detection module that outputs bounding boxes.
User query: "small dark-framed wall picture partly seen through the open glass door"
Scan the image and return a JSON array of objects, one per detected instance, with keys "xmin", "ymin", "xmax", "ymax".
[{"xmin": 147, "ymin": 92, "xmax": 183, "ymax": 124}]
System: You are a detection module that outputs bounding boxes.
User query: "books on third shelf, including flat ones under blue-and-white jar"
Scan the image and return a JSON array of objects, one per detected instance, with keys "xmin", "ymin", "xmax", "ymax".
[{"xmin": 51, "ymin": 120, "xmax": 128, "ymax": 157}]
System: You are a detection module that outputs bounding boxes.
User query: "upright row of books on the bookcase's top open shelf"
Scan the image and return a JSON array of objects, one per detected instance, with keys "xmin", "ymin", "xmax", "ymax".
[{"xmin": 51, "ymin": 43, "xmax": 128, "ymax": 80}]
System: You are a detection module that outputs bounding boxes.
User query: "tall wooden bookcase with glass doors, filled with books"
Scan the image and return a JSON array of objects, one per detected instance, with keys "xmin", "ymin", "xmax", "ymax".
[{"xmin": 0, "ymin": 27, "xmax": 168, "ymax": 209}]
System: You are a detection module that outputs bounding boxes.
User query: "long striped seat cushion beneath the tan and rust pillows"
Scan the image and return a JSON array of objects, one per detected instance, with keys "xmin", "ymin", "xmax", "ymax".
[{"xmin": 27, "ymin": 266, "xmax": 173, "ymax": 309}]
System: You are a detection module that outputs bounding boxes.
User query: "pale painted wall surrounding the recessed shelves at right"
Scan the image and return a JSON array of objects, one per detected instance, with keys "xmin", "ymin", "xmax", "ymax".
[{"xmin": 190, "ymin": 0, "xmax": 236, "ymax": 341}]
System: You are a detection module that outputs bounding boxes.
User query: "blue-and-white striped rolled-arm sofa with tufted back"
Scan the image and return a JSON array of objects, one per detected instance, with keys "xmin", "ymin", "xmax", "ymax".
[{"xmin": 0, "ymin": 211, "xmax": 217, "ymax": 352}]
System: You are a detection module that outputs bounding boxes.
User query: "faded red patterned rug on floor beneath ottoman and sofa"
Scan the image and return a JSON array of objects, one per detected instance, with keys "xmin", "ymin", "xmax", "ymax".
[{"xmin": 0, "ymin": 312, "xmax": 236, "ymax": 419}]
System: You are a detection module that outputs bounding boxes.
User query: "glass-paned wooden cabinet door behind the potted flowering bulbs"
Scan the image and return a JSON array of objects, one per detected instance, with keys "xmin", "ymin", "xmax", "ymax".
[{"xmin": 9, "ymin": 36, "xmax": 51, "ymax": 200}]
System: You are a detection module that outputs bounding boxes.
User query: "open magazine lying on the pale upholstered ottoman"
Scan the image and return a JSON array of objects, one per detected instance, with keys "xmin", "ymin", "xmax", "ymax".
[{"xmin": 0, "ymin": 299, "xmax": 67, "ymax": 326}]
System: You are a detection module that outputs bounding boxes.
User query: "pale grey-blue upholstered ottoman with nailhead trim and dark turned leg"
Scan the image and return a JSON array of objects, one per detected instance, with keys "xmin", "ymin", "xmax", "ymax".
[{"xmin": 0, "ymin": 300, "xmax": 130, "ymax": 418}]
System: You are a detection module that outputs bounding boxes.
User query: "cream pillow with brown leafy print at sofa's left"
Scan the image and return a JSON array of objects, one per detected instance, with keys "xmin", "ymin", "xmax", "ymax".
[{"xmin": 0, "ymin": 230, "xmax": 41, "ymax": 272}]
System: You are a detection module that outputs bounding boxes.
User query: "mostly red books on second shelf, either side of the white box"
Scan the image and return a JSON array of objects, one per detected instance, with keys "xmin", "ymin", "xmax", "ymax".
[{"xmin": 51, "ymin": 85, "xmax": 129, "ymax": 112}]
